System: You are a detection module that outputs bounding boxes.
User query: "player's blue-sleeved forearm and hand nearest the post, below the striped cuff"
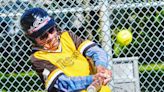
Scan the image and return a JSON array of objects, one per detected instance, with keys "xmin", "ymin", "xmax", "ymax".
[{"xmin": 84, "ymin": 45, "xmax": 112, "ymax": 85}]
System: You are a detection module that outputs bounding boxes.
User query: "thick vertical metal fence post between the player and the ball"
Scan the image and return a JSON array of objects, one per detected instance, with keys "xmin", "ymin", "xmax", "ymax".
[{"xmin": 100, "ymin": 0, "xmax": 114, "ymax": 91}]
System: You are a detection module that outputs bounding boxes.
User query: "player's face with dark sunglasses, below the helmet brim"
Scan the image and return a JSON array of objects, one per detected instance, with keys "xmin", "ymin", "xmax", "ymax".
[{"xmin": 35, "ymin": 28, "xmax": 59, "ymax": 50}]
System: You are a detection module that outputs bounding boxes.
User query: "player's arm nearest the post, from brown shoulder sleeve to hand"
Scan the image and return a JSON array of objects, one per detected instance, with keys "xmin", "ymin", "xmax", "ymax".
[{"xmin": 67, "ymin": 32, "xmax": 112, "ymax": 85}]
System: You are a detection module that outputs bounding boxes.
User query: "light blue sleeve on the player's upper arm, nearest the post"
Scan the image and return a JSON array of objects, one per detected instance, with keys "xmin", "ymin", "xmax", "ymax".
[{"xmin": 84, "ymin": 45, "xmax": 109, "ymax": 67}]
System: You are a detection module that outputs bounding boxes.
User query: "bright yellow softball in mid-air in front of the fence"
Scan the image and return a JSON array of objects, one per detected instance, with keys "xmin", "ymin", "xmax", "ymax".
[{"xmin": 117, "ymin": 29, "xmax": 132, "ymax": 46}]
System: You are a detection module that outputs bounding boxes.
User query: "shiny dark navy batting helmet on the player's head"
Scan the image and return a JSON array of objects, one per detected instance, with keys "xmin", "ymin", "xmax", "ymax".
[{"xmin": 20, "ymin": 8, "xmax": 55, "ymax": 38}]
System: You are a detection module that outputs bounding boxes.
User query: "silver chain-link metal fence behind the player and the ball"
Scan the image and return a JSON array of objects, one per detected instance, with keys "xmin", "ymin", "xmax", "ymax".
[{"xmin": 0, "ymin": 0, "xmax": 164, "ymax": 92}]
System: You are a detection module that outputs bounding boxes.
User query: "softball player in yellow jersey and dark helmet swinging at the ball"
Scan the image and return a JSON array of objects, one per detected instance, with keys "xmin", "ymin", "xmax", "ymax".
[{"xmin": 20, "ymin": 8, "xmax": 111, "ymax": 92}]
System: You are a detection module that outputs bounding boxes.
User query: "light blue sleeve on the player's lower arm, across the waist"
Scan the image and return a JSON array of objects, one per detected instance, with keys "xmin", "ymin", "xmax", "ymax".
[{"xmin": 54, "ymin": 74, "xmax": 93, "ymax": 92}]
